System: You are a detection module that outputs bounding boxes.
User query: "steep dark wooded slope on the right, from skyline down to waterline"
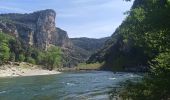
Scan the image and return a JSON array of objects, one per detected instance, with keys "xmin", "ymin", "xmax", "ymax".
[{"xmin": 88, "ymin": 0, "xmax": 170, "ymax": 71}]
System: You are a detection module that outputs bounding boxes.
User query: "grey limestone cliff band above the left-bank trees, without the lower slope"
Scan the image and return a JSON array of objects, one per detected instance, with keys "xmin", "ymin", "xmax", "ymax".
[{"xmin": 0, "ymin": 9, "xmax": 71, "ymax": 50}]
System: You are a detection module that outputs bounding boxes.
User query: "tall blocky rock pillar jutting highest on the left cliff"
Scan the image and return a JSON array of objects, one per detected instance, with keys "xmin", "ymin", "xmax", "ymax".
[{"xmin": 34, "ymin": 10, "xmax": 57, "ymax": 49}]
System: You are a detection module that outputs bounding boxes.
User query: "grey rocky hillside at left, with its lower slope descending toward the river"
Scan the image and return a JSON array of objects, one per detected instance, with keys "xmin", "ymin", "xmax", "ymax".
[{"xmin": 0, "ymin": 9, "xmax": 89, "ymax": 67}]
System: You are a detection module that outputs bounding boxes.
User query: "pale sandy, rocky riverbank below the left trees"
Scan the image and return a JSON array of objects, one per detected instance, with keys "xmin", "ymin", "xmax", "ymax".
[{"xmin": 0, "ymin": 62, "xmax": 61, "ymax": 77}]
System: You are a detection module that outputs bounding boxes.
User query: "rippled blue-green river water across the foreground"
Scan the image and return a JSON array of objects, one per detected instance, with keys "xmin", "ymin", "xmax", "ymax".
[{"xmin": 0, "ymin": 71, "xmax": 139, "ymax": 100}]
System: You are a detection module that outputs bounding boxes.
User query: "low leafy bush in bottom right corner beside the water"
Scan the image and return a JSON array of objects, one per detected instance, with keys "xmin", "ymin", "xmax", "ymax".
[{"xmin": 120, "ymin": 51, "xmax": 170, "ymax": 100}]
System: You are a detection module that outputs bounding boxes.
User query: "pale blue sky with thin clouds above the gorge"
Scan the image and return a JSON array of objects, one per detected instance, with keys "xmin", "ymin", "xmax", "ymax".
[{"xmin": 0, "ymin": 0, "xmax": 133, "ymax": 38}]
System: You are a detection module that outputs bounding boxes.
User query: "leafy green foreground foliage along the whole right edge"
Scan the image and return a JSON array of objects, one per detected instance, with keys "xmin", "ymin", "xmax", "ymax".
[{"xmin": 114, "ymin": 0, "xmax": 170, "ymax": 100}]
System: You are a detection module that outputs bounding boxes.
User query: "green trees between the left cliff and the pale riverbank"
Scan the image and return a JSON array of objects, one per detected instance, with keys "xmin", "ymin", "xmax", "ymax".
[{"xmin": 0, "ymin": 33, "xmax": 61, "ymax": 70}]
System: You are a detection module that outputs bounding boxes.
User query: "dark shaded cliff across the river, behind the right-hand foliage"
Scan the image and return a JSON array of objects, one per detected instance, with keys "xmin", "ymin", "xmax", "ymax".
[{"xmin": 87, "ymin": 32, "xmax": 148, "ymax": 71}]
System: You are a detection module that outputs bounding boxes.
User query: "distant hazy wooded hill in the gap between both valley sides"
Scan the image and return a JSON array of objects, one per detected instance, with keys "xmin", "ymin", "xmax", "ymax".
[{"xmin": 71, "ymin": 37, "xmax": 110, "ymax": 56}]
